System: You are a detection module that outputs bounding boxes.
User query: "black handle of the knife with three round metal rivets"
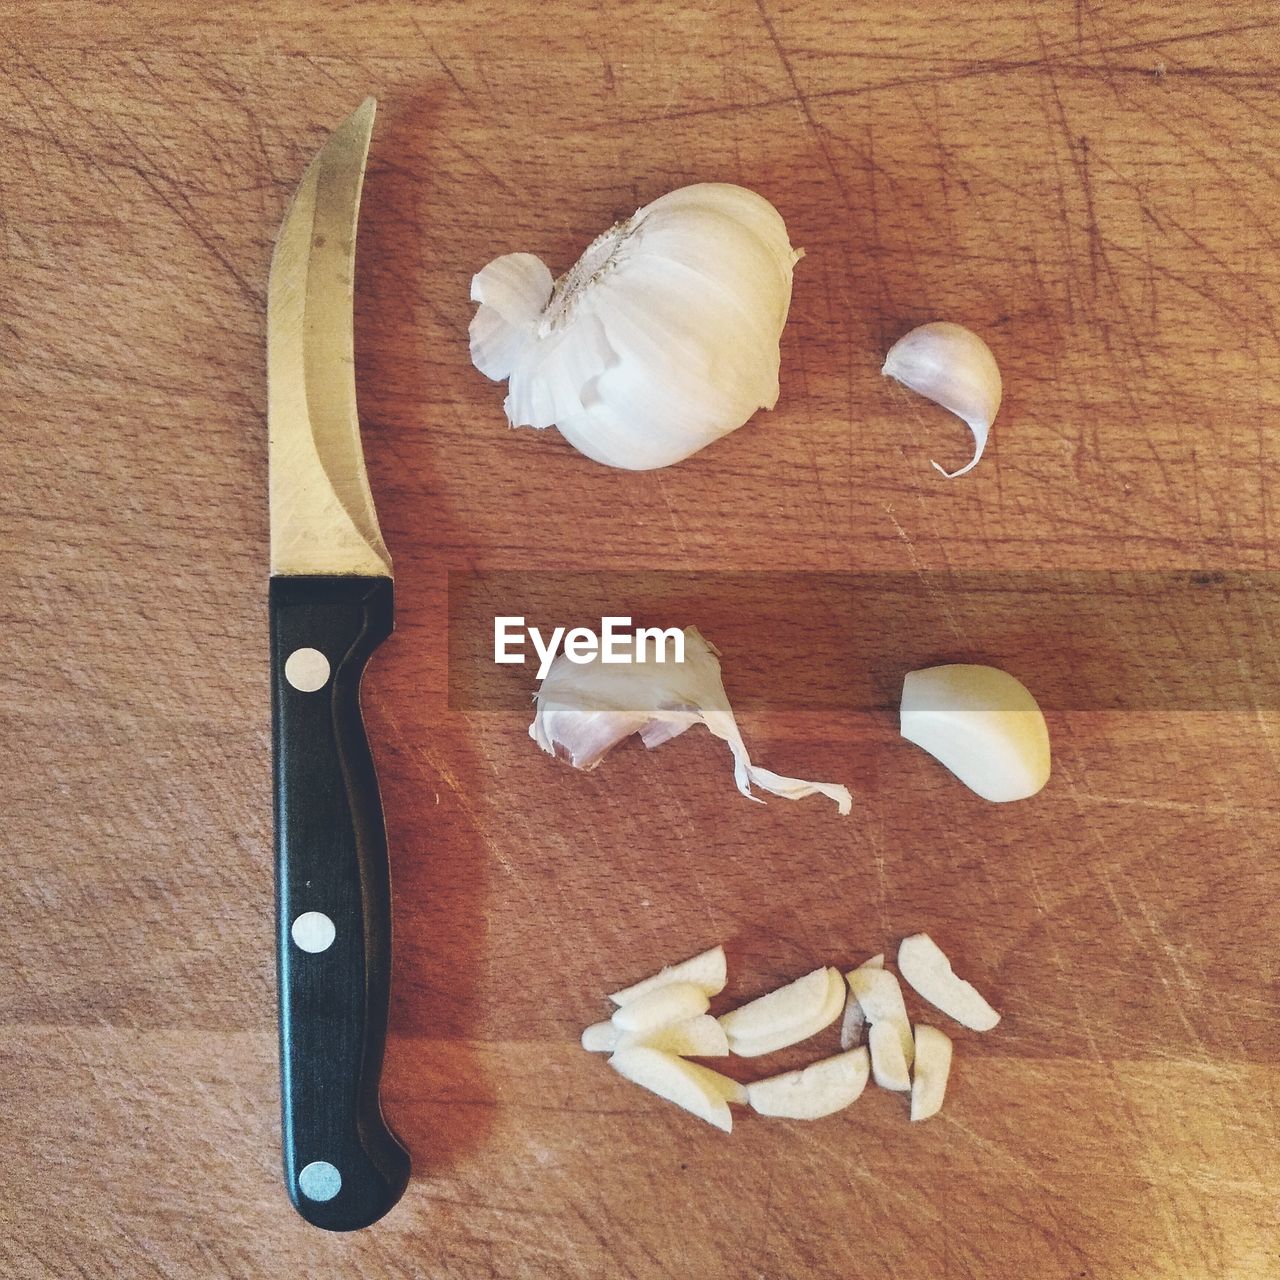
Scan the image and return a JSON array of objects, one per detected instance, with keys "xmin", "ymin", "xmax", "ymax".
[{"xmin": 270, "ymin": 577, "xmax": 410, "ymax": 1231}]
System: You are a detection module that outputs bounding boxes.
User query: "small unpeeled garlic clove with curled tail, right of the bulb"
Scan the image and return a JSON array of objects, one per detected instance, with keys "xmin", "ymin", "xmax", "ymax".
[{"xmin": 881, "ymin": 320, "xmax": 1004, "ymax": 480}]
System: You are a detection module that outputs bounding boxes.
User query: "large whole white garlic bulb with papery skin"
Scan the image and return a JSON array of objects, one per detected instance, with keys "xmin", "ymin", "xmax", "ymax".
[{"xmin": 471, "ymin": 183, "xmax": 801, "ymax": 471}]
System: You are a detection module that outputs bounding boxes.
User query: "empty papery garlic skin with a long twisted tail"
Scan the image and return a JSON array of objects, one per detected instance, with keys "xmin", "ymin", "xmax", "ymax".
[{"xmin": 529, "ymin": 627, "xmax": 852, "ymax": 814}]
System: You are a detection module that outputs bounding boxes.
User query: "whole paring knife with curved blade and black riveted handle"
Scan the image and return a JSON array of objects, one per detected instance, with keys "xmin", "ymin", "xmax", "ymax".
[{"xmin": 266, "ymin": 99, "xmax": 410, "ymax": 1231}]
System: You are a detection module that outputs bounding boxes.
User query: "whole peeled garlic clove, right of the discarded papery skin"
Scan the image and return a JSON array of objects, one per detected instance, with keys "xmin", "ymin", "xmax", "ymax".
[{"xmin": 901, "ymin": 663, "xmax": 1050, "ymax": 804}]
